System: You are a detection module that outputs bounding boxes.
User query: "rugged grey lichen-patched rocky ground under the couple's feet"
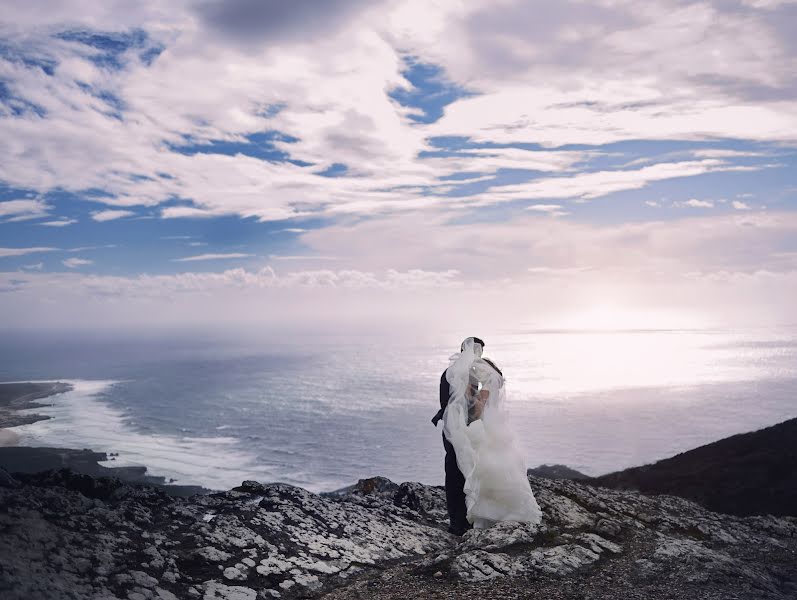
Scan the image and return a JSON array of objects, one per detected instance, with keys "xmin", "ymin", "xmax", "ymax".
[{"xmin": 0, "ymin": 470, "xmax": 797, "ymax": 600}]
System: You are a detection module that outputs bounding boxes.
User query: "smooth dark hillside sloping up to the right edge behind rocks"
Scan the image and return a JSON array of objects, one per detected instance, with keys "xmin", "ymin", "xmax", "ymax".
[{"xmin": 591, "ymin": 419, "xmax": 797, "ymax": 516}]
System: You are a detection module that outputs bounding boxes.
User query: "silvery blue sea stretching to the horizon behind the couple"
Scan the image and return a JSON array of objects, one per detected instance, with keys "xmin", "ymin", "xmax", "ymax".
[{"xmin": 0, "ymin": 327, "xmax": 797, "ymax": 491}]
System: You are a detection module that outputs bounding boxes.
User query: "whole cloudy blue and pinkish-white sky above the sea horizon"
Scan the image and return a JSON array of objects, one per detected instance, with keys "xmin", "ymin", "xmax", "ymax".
[{"xmin": 0, "ymin": 0, "xmax": 797, "ymax": 332}]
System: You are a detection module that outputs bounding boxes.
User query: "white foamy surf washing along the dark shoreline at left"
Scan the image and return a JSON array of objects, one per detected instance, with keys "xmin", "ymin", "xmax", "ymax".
[{"xmin": 15, "ymin": 380, "xmax": 276, "ymax": 489}]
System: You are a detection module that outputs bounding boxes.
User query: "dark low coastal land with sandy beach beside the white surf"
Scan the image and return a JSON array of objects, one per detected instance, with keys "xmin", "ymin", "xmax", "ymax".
[{"xmin": 0, "ymin": 381, "xmax": 210, "ymax": 496}]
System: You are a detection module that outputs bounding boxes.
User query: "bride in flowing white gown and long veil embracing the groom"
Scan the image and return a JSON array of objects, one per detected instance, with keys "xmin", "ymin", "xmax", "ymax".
[{"xmin": 443, "ymin": 338, "xmax": 542, "ymax": 529}]
